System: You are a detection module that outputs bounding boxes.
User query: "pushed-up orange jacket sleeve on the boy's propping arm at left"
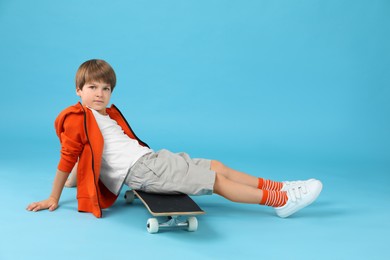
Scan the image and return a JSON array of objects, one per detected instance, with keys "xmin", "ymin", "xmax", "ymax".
[{"xmin": 55, "ymin": 111, "xmax": 85, "ymax": 172}]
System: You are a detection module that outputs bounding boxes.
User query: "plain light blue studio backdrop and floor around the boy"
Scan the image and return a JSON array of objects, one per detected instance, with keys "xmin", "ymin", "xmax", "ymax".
[{"xmin": 0, "ymin": 0, "xmax": 390, "ymax": 259}]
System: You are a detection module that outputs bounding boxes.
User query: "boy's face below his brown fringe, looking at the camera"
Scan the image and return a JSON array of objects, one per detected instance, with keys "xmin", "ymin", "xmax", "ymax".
[{"xmin": 76, "ymin": 82, "xmax": 111, "ymax": 115}]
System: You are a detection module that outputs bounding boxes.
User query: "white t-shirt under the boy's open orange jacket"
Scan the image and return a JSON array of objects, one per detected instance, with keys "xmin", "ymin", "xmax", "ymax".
[{"xmin": 91, "ymin": 109, "xmax": 153, "ymax": 195}]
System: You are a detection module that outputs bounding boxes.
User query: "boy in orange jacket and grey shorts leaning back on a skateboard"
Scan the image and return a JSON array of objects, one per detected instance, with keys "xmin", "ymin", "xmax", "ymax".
[{"xmin": 27, "ymin": 60, "xmax": 322, "ymax": 218}]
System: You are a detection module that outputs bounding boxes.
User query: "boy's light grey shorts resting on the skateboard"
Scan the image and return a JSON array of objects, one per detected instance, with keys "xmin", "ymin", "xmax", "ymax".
[{"xmin": 125, "ymin": 150, "xmax": 215, "ymax": 195}]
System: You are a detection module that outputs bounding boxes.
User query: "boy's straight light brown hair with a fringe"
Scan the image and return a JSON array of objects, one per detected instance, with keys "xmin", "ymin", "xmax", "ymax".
[{"xmin": 76, "ymin": 59, "xmax": 116, "ymax": 92}]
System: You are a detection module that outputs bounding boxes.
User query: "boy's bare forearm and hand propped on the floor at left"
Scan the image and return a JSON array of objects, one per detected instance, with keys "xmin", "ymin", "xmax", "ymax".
[{"xmin": 27, "ymin": 170, "xmax": 69, "ymax": 211}]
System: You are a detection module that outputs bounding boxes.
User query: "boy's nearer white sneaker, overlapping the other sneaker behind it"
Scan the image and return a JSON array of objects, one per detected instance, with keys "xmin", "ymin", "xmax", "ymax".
[{"xmin": 275, "ymin": 179, "xmax": 322, "ymax": 218}]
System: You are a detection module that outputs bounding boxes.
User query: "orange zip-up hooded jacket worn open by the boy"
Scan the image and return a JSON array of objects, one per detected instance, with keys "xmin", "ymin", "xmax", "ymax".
[{"xmin": 54, "ymin": 103, "xmax": 148, "ymax": 218}]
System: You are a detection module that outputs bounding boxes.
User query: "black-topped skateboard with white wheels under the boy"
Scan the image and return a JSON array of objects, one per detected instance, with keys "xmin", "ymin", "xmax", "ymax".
[{"xmin": 125, "ymin": 190, "xmax": 205, "ymax": 234}]
